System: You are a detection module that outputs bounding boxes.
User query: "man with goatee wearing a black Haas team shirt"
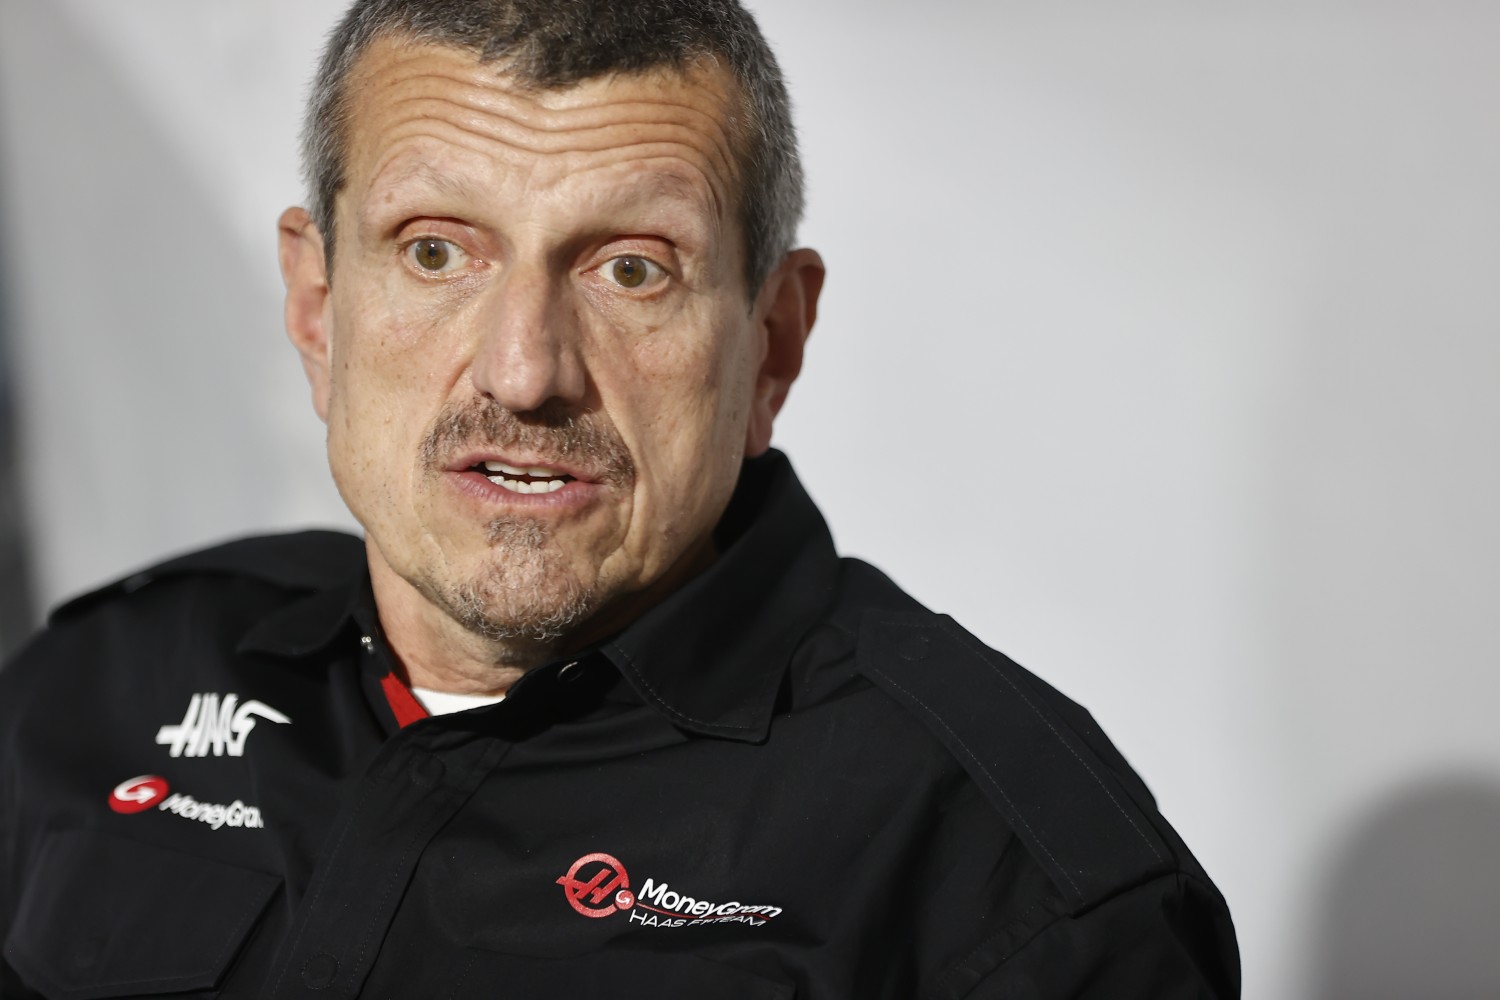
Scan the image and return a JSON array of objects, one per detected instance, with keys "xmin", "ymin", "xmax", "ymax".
[{"xmin": 0, "ymin": 0, "xmax": 1238, "ymax": 999}]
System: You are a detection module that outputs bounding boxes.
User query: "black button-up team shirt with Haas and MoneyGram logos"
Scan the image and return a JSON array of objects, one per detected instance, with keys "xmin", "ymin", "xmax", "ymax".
[{"xmin": 0, "ymin": 453, "xmax": 1239, "ymax": 1000}]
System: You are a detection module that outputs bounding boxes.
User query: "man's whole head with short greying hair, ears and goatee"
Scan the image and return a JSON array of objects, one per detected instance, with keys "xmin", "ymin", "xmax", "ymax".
[{"xmin": 282, "ymin": 0, "xmax": 822, "ymax": 680}]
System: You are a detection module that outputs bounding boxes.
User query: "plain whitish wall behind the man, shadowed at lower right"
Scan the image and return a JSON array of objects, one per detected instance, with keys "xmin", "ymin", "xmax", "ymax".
[{"xmin": 0, "ymin": 0, "xmax": 1500, "ymax": 1000}]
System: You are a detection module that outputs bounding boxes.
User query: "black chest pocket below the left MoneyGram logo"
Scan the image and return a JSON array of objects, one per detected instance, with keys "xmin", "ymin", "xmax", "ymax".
[{"xmin": 5, "ymin": 831, "xmax": 281, "ymax": 1000}]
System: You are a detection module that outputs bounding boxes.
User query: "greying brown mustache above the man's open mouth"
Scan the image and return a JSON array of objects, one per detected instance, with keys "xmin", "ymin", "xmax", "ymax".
[{"xmin": 422, "ymin": 396, "xmax": 636, "ymax": 486}]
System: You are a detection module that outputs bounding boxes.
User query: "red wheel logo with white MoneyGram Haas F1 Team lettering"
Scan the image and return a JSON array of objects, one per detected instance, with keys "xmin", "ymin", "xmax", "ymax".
[{"xmin": 557, "ymin": 855, "xmax": 782, "ymax": 928}]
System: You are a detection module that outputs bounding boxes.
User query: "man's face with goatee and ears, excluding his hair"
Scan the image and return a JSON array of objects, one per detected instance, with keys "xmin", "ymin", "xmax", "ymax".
[{"xmin": 282, "ymin": 42, "xmax": 821, "ymax": 659}]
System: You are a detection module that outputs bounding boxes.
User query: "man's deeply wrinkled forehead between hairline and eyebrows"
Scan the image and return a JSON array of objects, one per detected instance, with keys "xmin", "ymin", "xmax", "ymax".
[{"xmin": 345, "ymin": 37, "xmax": 737, "ymax": 223}]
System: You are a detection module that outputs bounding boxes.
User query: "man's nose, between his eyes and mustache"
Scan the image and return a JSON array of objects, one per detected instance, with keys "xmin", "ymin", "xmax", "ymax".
[{"xmin": 470, "ymin": 264, "xmax": 587, "ymax": 414}]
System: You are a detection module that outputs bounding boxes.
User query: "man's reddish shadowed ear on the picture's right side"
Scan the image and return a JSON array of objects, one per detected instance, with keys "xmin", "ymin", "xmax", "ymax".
[{"xmin": 746, "ymin": 249, "xmax": 825, "ymax": 457}]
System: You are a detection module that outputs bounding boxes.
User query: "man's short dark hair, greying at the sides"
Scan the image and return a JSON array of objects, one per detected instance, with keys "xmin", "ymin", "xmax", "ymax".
[{"xmin": 302, "ymin": 0, "xmax": 803, "ymax": 301}]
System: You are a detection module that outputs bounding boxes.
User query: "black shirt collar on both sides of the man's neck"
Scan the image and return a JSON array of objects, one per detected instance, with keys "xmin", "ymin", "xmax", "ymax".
[{"xmin": 239, "ymin": 451, "xmax": 839, "ymax": 742}]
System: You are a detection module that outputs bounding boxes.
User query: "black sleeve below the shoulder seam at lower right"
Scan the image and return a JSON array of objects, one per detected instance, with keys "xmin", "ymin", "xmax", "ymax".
[{"xmin": 941, "ymin": 873, "xmax": 1239, "ymax": 1000}]
